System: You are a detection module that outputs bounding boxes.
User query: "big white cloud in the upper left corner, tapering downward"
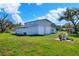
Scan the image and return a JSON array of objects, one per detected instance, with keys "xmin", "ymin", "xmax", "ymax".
[{"xmin": 0, "ymin": 3, "xmax": 23, "ymax": 24}]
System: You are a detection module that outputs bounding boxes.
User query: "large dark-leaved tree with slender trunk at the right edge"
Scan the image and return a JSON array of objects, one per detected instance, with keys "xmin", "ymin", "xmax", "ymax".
[{"xmin": 59, "ymin": 8, "xmax": 79, "ymax": 34}]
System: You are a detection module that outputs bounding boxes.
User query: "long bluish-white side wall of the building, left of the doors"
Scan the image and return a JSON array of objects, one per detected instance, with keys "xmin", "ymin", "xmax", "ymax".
[{"xmin": 15, "ymin": 26, "xmax": 38, "ymax": 35}]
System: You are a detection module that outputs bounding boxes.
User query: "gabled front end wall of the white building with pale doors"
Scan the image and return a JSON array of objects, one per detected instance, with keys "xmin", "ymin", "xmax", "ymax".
[{"xmin": 38, "ymin": 21, "xmax": 52, "ymax": 35}]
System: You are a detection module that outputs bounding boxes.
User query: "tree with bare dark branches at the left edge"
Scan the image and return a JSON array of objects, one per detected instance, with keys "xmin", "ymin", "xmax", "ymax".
[{"xmin": 0, "ymin": 12, "xmax": 13, "ymax": 32}]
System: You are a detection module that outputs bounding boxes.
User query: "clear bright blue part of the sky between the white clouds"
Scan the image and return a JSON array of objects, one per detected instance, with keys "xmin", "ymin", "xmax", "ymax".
[{"xmin": 19, "ymin": 3, "xmax": 79, "ymax": 24}]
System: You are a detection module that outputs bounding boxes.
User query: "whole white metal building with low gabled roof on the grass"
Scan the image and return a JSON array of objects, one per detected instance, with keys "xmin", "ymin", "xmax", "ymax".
[{"xmin": 15, "ymin": 19, "xmax": 56, "ymax": 35}]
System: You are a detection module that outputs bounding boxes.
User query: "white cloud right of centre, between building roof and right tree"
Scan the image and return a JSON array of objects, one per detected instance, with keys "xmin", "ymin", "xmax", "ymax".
[{"xmin": 37, "ymin": 8, "xmax": 66, "ymax": 24}]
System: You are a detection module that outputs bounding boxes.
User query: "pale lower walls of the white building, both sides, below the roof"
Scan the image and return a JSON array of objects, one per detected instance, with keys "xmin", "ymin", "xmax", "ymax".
[{"xmin": 16, "ymin": 26, "xmax": 56, "ymax": 35}]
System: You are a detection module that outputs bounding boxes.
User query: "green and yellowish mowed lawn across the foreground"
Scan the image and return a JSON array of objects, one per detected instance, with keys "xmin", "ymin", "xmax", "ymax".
[{"xmin": 0, "ymin": 33, "xmax": 79, "ymax": 56}]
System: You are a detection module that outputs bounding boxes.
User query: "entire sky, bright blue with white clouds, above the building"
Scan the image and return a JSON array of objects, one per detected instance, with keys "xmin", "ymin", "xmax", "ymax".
[{"xmin": 0, "ymin": 3, "xmax": 79, "ymax": 25}]
